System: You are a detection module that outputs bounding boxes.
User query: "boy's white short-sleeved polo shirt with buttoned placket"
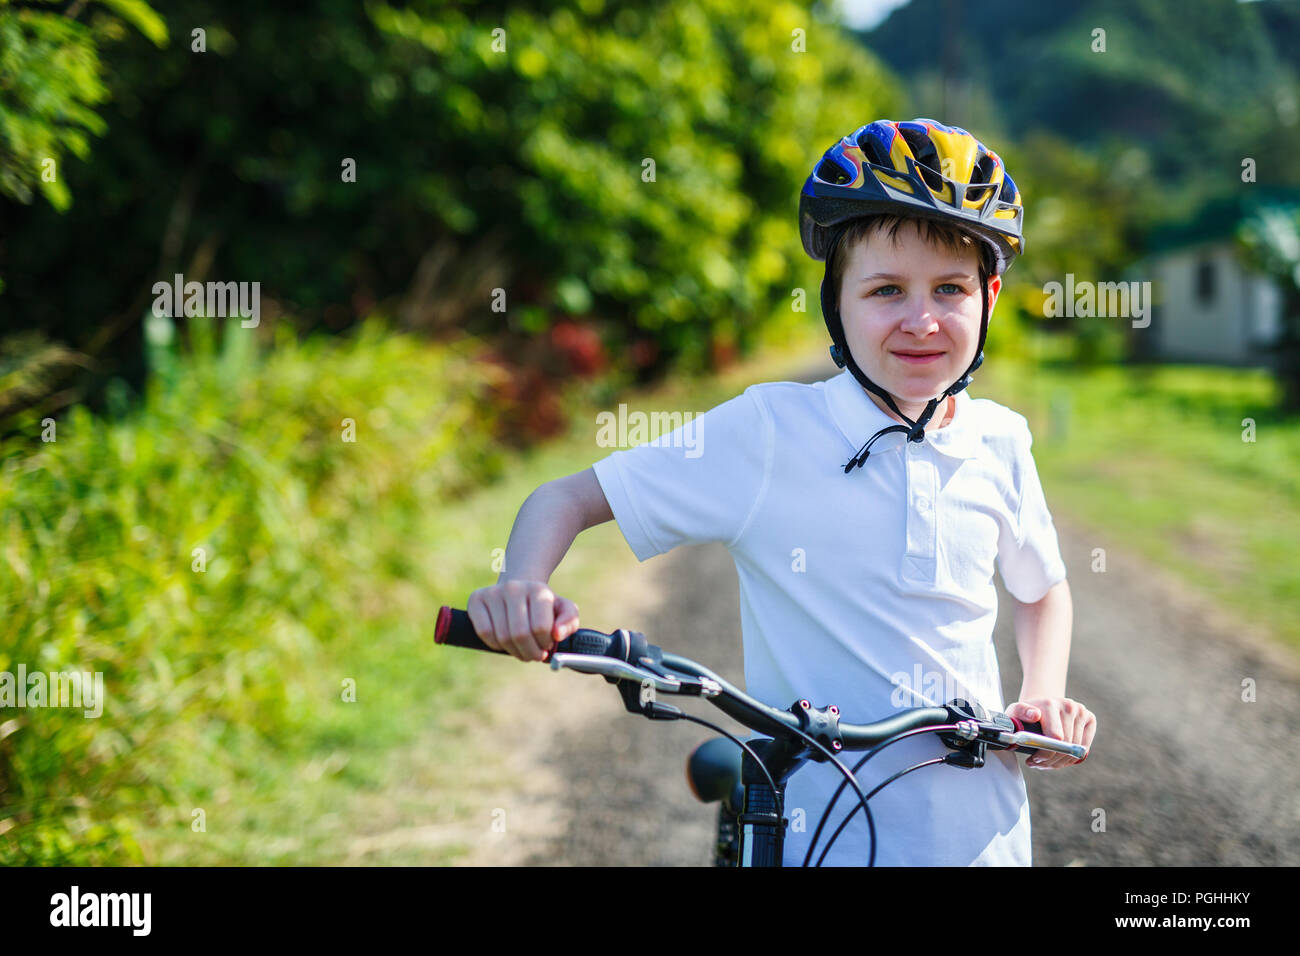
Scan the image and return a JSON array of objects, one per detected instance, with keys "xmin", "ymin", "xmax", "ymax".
[{"xmin": 593, "ymin": 371, "xmax": 1066, "ymax": 866}]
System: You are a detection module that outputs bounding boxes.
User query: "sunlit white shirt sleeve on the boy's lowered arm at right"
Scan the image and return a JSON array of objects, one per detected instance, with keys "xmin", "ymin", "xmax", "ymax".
[{"xmin": 997, "ymin": 419, "xmax": 1066, "ymax": 604}]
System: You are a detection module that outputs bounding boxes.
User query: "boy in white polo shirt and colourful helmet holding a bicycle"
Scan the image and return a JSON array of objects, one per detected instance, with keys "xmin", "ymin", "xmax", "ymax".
[{"xmin": 467, "ymin": 120, "xmax": 1096, "ymax": 866}]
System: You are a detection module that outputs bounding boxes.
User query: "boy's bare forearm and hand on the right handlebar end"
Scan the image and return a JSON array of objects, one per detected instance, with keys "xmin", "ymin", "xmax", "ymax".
[{"xmin": 1008, "ymin": 580, "xmax": 1097, "ymax": 770}]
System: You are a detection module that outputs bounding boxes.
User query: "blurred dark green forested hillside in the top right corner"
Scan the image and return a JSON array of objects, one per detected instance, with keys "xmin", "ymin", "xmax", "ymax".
[{"xmin": 862, "ymin": 0, "xmax": 1300, "ymax": 185}]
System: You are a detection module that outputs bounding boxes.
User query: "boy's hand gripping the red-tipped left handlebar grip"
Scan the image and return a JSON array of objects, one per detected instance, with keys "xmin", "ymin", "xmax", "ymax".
[{"xmin": 465, "ymin": 580, "xmax": 579, "ymax": 661}]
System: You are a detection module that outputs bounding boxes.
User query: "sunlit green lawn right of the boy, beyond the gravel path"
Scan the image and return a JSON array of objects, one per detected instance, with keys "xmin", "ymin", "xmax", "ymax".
[{"xmin": 971, "ymin": 348, "xmax": 1300, "ymax": 648}]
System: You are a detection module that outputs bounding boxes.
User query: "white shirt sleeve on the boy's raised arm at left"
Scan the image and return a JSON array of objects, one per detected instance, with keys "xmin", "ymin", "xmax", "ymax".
[{"xmin": 592, "ymin": 389, "xmax": 774, "ymax": 561}]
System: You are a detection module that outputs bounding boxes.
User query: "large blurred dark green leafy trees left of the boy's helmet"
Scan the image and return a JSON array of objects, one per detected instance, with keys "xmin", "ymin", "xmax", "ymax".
[{"xmin": 0, "ymin": 0, "xmax": 894, "ymax": 411}]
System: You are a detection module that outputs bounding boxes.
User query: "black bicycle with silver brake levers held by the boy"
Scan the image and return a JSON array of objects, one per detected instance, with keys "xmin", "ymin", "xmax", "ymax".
[{"xmin": 434, "ymin": 606, "xmax": 1088, "ymax": 866}]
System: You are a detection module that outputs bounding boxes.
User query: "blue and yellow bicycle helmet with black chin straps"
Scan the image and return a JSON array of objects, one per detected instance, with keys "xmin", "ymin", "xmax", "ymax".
[{"xmin": 800, "ymin": 120, "xmax": 1024, "ymax": 473}]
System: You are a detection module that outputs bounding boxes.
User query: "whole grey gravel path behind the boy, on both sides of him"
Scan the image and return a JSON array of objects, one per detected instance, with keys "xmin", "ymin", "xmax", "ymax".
[{"xmin": 449, "ymin": 369, "xmax": 1300, "ymax": 866}]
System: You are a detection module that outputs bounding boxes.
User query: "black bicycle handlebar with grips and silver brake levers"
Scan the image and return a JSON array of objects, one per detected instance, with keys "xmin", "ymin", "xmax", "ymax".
[{"xmin": 434, "ymin": 606, "xmax": 1088, "ymax": 761}]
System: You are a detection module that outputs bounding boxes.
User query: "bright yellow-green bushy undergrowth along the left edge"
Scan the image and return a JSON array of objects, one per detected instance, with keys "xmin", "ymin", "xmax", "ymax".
[{"xmin": 0, "ymin": 323, "xmax": 501, "ymax": 865}]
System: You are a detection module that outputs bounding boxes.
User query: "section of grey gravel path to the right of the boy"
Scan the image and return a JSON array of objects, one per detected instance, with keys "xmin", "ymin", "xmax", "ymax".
[{"xmin": 997, "ymin": 519, "xmax": 1300, "ymax": 866}]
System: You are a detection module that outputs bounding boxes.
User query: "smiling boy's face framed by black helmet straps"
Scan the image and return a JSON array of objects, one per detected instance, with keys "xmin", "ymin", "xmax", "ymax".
[{"xmin": 840, "ymin": 222, "xmax": 1002, "ymax": 411}]
